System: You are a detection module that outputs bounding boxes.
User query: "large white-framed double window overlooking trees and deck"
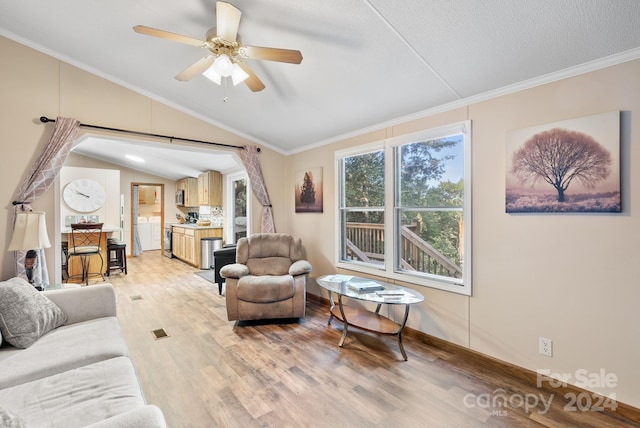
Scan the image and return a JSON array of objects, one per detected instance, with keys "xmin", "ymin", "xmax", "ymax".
[{"xmin": 336, "ymin": 121, "xmax": 471, "ymax": 294}]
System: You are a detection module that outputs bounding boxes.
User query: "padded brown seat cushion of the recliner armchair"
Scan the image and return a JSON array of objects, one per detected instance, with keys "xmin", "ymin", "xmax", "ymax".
[{"xmin": 236, "ymin": 275, "xmax": 294, "ymax": 303}]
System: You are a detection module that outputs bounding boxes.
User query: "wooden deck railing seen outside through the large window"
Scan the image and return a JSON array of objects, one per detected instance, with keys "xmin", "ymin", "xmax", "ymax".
[{"xmin": 346, "ymin": 223, "xmax": 462, "ymax": 278}]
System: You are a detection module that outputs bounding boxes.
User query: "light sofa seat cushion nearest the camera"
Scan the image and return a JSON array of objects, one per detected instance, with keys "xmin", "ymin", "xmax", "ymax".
[{"xmin": 0, "ymin": 357, "xmax": 145, "ymax": 428}]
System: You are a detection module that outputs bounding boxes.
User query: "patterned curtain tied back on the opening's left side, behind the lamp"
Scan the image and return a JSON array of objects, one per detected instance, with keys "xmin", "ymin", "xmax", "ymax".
[{"xmin": 13, "ymin": 117, "xmax": 80, "ymax": 284}]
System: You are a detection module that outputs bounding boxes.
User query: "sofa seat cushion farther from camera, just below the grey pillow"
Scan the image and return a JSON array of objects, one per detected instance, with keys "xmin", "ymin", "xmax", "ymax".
[{"xmin": 0, "ymin": 317, "xmax": 128, "ymax": 388}]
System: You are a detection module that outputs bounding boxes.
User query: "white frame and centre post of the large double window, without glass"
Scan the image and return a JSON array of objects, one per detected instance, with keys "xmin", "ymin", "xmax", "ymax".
[{"xmin": 335, "ymin": 120, "xmax": 473, "ymax": 296}]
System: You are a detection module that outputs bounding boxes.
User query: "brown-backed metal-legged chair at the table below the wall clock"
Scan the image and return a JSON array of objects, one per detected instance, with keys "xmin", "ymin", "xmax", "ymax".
[{"xmin": 67, "ymin": 223, "xmax": 104, "ymax": 285}]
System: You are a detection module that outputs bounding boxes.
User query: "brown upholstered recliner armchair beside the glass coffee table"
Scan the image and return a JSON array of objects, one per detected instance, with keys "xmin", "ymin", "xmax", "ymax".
[{"xmin": 220, "ymin": 233, "xmax": 311, "ymax": 321}]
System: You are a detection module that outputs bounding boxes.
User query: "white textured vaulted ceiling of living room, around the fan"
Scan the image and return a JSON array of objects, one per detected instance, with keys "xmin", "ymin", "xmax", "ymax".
[{"xmin": 0, "ymin": 0, "xmax": 640, "ymax": 176}]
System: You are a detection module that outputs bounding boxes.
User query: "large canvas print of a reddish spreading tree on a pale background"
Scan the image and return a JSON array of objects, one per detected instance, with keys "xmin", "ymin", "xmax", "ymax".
[{"xmin": 505, "ymin": 111, "xmax": 621, "ymax": 213}]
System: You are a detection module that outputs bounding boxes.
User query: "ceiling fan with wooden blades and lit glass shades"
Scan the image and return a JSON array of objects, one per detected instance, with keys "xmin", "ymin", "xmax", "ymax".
[{"xmin": 133, "ymin": 1, "xmax": 302, "ymax": 92}]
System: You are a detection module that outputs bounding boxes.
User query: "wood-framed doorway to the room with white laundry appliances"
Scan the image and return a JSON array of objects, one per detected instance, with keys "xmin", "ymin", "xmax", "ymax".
[{"xmin": 130, "ymin": 182, "xmax": 164, "ymax": 256}]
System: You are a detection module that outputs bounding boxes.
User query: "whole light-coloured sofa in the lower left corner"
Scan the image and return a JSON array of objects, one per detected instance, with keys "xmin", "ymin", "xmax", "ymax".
[{"xmin": 0, "ymin": 278, "xmax": 166, "ymax": 428}]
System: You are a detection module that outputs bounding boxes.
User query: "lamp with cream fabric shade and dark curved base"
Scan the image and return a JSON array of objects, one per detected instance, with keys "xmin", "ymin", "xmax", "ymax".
[{"xmin": 9, "ymin": 211, "xmax": 51, "ymax": 289}]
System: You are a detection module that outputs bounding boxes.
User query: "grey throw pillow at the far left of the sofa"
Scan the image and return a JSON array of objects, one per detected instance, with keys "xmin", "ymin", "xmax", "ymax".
[{"xmin": 0, "ymin": 277, "xmax": 67, "ymax": 348}]
